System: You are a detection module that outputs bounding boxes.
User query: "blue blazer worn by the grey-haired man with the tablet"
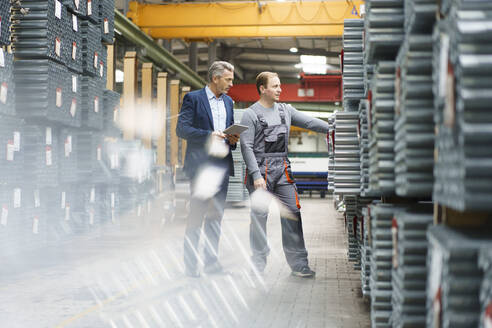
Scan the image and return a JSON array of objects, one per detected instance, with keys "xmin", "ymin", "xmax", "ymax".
[{"xmin": 176, "ymin": 88, "xmax": 236, "ymax": 178}]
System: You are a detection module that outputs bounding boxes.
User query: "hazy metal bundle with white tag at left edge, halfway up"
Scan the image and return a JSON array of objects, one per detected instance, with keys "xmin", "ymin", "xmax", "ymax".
[{"xmin": 0, "ymin": 115, "xmax": 25, "ymax": 185}]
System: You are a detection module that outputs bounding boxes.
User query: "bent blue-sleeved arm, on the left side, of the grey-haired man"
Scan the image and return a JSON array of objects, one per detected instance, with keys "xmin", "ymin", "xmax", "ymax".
[{"xmin": 176, "ymin": 94, "xmax": 212, "ymax": 143}]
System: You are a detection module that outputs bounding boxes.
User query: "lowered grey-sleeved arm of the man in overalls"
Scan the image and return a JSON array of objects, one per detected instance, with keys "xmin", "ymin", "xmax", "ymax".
[{"xmin": 239, "ymin": 110, "xmax": 262, "ymax": 180}]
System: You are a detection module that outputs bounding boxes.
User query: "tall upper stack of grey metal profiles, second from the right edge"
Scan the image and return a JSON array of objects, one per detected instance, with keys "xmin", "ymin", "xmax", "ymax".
[{"xmin": 394, "ymin": 34, "xmax": 434, "ymax": 197}]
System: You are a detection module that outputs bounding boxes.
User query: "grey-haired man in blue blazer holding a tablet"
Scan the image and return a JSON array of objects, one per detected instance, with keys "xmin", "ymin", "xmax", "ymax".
[{"xmin": 176, "ymin": 61, "xmax": 239, "ymax": 278}]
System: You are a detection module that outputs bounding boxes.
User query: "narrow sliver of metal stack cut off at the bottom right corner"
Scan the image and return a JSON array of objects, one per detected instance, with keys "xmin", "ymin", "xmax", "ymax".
[{"xmin": 478, "ymin": 248, "xmax": 492, "ymax": 328}]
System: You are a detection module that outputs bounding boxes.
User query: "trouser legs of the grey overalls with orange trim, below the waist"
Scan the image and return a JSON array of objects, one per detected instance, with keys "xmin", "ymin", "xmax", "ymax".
[{"xmin": 246, "ymin": 158, "xmax": 308, "ymax": 271}]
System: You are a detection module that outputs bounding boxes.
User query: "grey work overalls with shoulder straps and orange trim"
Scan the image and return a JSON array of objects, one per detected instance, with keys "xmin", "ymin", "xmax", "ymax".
[{"xmin": 245, "ymin": 104, "xmax": 308, "ymax": 271}]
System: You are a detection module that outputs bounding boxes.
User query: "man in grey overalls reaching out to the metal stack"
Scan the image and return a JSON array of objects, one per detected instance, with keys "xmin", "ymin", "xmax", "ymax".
[{"xmin": 240, "ymin": 72, "xmax": 329, "ymax": 278}]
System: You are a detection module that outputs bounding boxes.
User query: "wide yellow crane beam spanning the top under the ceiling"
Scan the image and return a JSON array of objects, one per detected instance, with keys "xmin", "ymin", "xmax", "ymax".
[{"xmin": 127, "ymin": 0, "xmax": 364, "ymax": 39}]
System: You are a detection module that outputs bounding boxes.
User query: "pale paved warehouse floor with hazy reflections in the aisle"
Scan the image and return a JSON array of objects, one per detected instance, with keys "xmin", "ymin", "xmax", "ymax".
[{"xmin": 0, "ymin": 198, "xmax": 370, "ymax": 328}]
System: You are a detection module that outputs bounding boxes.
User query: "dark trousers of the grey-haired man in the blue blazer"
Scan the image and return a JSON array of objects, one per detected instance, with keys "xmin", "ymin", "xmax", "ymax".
[{"xmin": 184, "ymin": 170, "xmax": 229, "ymax": 272}]
